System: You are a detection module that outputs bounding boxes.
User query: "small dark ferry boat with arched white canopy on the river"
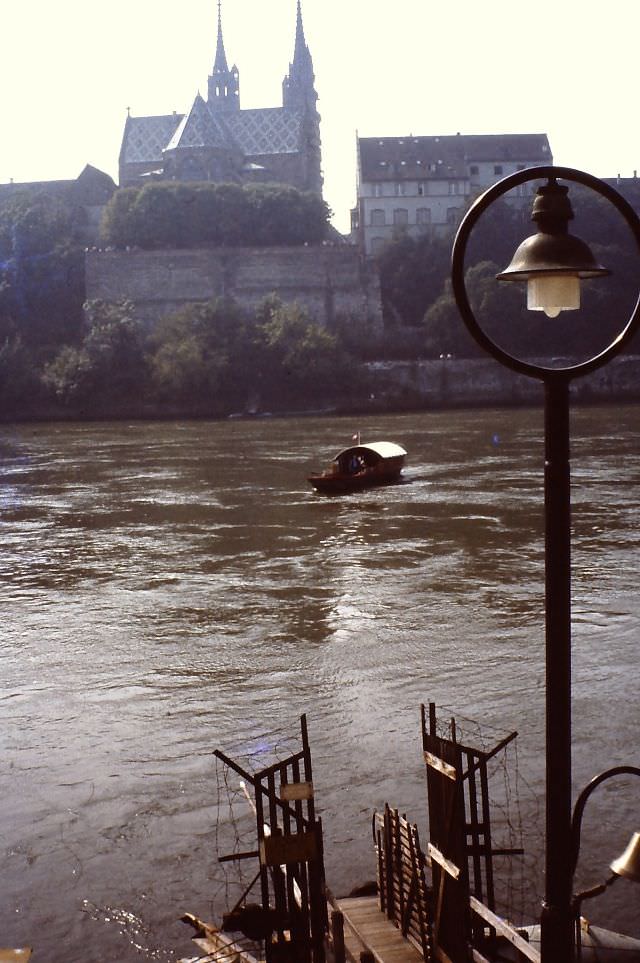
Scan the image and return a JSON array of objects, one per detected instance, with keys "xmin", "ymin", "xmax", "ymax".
[{"xmin": 308, "ymin": 441, "xmax": 407, "ymax": 495}]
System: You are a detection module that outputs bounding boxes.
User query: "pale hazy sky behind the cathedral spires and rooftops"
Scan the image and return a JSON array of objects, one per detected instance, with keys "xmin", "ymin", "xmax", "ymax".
[{"xmin": 0, "ymin": 0, "xmax": 640, "ymax": 229}]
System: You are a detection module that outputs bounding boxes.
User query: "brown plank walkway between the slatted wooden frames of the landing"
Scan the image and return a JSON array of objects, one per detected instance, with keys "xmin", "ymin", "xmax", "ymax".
[{"xmin": 336, "ymin": 896, "xmax": 424, "ymax": 963}]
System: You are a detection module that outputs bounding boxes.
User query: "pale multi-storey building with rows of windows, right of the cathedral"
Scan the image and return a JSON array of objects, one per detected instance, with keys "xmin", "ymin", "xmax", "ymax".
[{"xmin": 352, "ymin": 134, "xmax": 553, "ymax": 255}]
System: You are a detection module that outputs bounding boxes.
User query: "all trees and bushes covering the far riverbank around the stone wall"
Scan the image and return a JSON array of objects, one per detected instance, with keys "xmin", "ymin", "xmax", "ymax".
[{"xmin": 0, "ymin": 183, "xmax": 640, "ymax": 422}]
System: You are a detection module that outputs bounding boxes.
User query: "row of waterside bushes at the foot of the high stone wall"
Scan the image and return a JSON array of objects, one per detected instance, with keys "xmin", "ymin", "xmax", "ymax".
[{"xmin": 0, "ymin": 296, "xmax": 365, "ymax": 417}]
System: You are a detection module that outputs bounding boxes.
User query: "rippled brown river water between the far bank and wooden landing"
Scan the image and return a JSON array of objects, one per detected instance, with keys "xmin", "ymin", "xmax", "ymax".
[{"xmin": 0, "ymin": 407, "xmax": 640, "ymax": 963}]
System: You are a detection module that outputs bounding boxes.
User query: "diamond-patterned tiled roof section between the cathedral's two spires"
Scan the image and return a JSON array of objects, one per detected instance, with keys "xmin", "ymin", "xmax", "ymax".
[{"xmin": 224, "ymin": 107, "xmax": 303, "ymax": 155}]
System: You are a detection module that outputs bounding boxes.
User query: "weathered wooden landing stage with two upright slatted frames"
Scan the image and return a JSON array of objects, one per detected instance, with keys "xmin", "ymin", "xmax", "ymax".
[{"xmin": 204, "ymin": 703, "xmax": 540, "ymax": 963}]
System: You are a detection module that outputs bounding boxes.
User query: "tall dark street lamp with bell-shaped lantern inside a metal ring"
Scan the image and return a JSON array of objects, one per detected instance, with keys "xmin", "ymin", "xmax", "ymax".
[{"xmin": 451, "ymin": 167, "xmax": 640, "ymax": 963}]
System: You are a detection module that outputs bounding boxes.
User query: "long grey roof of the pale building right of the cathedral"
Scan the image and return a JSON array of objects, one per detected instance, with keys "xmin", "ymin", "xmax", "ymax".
[{"xmin": 358, "ymin": 134, "xmax": 551, "ymax": 181}]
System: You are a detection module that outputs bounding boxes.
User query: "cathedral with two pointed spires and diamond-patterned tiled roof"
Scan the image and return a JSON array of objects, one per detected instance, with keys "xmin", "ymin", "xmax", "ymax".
[{"xmin": 119, "ymin": 0, "xmax": 322, "ymax": 194}]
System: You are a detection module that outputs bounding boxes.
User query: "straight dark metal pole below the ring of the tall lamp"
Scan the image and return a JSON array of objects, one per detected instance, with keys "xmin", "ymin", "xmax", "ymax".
[{"xmin": 540, "ymin": 376, "xmax": 574, "ymax": 963}]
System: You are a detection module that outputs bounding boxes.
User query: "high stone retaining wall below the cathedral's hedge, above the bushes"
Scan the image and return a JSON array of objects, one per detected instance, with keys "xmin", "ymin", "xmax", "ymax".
[{"xmin": 86, "ymin": 244, "xmax": 382, "ymax": 333}]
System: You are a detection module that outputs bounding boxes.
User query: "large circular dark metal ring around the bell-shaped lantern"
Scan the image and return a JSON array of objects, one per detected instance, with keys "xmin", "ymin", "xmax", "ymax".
[{"xmin": 451, "ymin": 166, "xmax": 640, "ymax": 381}]
